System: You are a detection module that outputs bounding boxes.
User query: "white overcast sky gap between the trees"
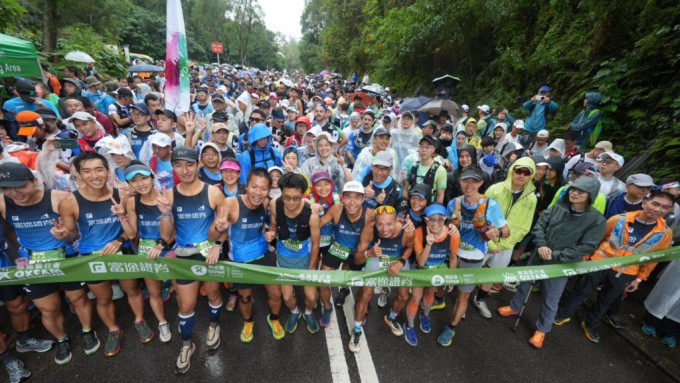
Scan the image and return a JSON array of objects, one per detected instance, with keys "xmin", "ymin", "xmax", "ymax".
[{"xmin": 259, "ymin": 0, "xmax": 305, "ymax": 40}]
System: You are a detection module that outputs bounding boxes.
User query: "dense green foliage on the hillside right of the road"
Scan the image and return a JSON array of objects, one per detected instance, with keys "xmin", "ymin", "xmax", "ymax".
[{"xmin": 300, "ymin": 0, "xmax": 680, "ymax": 176}]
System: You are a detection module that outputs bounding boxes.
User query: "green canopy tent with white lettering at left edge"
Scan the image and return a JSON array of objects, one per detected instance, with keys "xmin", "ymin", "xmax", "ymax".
[{"xmin": 0, "ymin": 33, "xmax": 42, "ymax": 78}]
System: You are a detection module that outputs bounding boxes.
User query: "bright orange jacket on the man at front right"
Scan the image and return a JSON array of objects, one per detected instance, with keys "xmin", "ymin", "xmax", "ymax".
[{"xmin": 590, "ymin": 211, "xmax": 673, "ymax": 281}]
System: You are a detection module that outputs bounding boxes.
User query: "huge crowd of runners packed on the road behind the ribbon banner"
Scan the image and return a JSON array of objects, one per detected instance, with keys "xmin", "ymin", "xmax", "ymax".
[{"xmin": 0, "ymin": 65, "xmax": 680, "ymax": 382}]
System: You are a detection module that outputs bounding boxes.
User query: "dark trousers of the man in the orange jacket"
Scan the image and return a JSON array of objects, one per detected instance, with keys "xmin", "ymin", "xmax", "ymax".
[{"xmin": 557, "ymin": 270, "xmax": 635, "ymax": 328}]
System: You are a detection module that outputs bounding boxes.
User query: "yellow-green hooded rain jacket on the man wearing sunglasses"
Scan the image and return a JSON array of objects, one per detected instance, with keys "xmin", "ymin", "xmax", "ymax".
[{"xmin": 484, "ymin": 157, "xmax": 537, "ymax": 250}]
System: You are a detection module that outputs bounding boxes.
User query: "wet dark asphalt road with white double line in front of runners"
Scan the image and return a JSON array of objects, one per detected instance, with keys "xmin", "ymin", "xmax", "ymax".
[{"xmin": 0, "ymin": 282, "xmax": 677, "ymax": 383}]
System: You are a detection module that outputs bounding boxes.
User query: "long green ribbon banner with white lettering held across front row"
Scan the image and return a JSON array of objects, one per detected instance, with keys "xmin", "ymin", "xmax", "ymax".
[{"xmin": 0, "ymin": 247, "xmax": 680, "ymax": 287}]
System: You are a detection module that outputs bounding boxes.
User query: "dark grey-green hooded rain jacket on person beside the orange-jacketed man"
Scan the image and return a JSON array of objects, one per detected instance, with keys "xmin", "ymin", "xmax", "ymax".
[{"xmin": 529, "ymin": 177, "xmax": 607, "ymax": 265}]
